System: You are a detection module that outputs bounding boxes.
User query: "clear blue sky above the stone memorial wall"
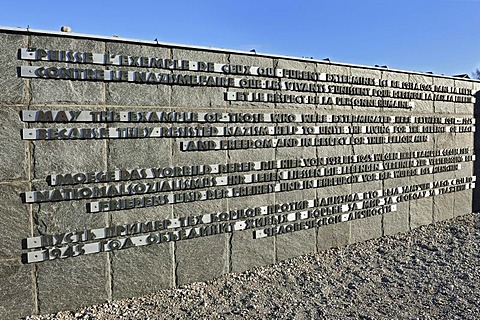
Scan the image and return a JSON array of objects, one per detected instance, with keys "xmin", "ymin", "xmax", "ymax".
[{"xmin": 0, "ymin": 0, "xmax": 480, "ymax": 75}]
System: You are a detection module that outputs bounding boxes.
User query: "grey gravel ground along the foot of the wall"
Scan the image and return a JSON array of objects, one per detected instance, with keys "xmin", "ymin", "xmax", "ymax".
[{"xmin": 25, "ymin": 214, "xmax": 480, "ymax": 320}]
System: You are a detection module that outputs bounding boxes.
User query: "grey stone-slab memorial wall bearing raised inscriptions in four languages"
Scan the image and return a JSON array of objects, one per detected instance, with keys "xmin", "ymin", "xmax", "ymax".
[{"xmin": 0, "ymin": 28, "xmax": 480, "ymax": 318}]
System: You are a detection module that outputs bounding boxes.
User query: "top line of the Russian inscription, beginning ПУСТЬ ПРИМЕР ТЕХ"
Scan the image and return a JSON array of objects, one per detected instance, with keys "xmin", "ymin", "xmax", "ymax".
[{"xmin": 26, "ymin": 176, "xmax": 476, "ymax": 249}]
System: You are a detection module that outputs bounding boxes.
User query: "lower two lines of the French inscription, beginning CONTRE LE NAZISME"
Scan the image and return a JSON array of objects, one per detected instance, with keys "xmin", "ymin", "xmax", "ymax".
[{"xmin": 19, "ymin": 66, "xmax": 475, "ymax": 109}]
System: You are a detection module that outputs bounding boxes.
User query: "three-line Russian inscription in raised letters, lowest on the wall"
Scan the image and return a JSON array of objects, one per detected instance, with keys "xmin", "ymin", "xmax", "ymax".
[{"xmin": 21, "ymin": 176, "xmax": 476, "ymax": 263}]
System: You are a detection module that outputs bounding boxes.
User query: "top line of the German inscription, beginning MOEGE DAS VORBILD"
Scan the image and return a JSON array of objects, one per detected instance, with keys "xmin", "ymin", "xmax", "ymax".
[{"xmin": 47, "ymin": 148, "xmax": 475, "ymax": 186}]
